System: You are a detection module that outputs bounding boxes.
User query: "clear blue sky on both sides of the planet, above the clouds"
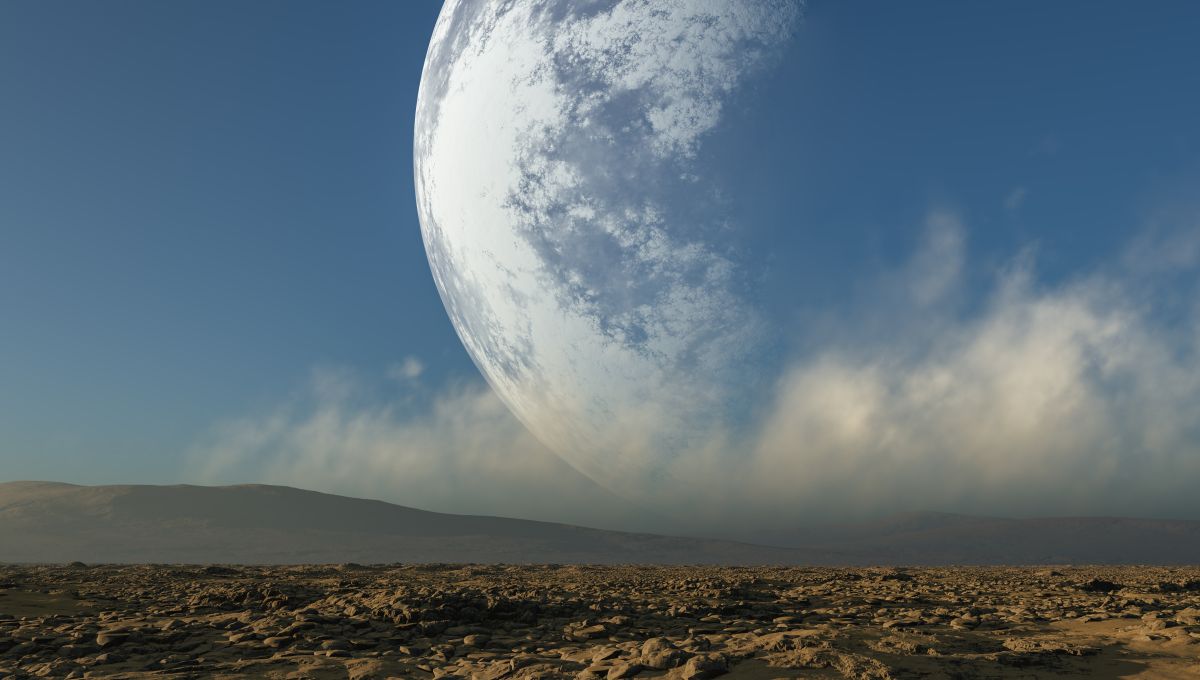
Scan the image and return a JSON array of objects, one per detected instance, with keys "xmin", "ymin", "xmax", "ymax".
[{"xmin": 0, "ymin": 0, "xmax": 1200, "ymax": 527}]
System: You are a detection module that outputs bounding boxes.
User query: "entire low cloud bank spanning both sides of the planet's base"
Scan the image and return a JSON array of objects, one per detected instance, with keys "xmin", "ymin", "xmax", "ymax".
[{"xmin": 192, "ymin": 212, "xmax": 1200, "ymax": 532}]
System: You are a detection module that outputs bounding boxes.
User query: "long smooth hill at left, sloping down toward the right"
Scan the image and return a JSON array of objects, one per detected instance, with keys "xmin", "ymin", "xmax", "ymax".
[{"xmin": 0, "ymin": 482, "xmax": 829, "ymax": 564}]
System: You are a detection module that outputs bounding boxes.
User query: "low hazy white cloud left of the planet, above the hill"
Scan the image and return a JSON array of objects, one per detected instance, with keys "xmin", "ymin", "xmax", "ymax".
[{"xmin": 190, "ymin": 371, "xmax": 632, "ymax": 524}]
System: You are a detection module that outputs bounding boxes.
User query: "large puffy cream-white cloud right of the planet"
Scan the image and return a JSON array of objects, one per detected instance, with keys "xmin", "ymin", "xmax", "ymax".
[{"xmin": 729, "ymin": 271, "xmax": 1200, "ymax": 514}]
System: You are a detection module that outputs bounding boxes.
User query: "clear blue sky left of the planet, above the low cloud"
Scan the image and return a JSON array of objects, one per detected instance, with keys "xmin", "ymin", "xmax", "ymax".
[{"xmin": 0, "ymin": 1, "xmax": 458, "ymax": 481}]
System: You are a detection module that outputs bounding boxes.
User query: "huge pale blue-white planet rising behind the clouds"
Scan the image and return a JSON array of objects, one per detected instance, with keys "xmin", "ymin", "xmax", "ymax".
[{"xmin": 414, "ymin": 0, "xmax": 800, "ymax": 488}]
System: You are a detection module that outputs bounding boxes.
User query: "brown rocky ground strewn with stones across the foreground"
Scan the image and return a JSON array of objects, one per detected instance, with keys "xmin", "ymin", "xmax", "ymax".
[{"xmin": 0, "ymin": 564, "xmax": 1200, "ymax": 680}]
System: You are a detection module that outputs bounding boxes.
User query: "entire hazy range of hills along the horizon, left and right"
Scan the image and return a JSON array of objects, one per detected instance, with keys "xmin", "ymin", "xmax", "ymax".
[{"xmin": 0, "ymin": 482, "xmax": 1200, "ymax": 565}]
